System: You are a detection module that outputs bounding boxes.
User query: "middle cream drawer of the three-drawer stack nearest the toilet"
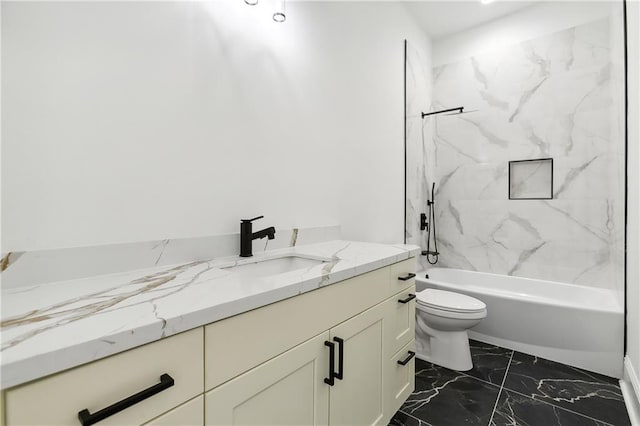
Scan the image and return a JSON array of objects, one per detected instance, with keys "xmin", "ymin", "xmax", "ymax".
[{"xmin": 385, "ymin": 286, "xmax": 416, "ymax": 357}]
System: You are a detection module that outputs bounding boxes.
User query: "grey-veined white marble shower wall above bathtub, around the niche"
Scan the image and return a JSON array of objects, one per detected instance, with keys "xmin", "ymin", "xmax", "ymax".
[{"xmin": 408, "ymin": 14, "xmax": 624, "ymax": 298}]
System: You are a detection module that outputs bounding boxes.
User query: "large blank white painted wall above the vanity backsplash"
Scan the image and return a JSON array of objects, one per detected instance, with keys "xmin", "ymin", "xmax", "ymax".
[{"xmin": 2, "ymin": 0, "xmax": 426, "ymax": 253}]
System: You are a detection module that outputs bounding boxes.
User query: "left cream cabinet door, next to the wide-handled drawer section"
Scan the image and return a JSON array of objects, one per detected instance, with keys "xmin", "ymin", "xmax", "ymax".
[{"xmin": 205, "ymin": 330, "xmax": 329, "ymax": 425}]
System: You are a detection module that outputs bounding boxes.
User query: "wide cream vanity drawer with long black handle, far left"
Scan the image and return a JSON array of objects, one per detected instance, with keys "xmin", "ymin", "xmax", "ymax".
[{"xmin": 5, "ymin": 328, "xmax": 204, "ymax": 426}]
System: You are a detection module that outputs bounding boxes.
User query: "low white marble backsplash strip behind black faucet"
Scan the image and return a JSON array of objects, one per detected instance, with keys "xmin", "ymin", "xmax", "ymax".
[{"xmin": 0, "ymin": 222, "xmax": 341, "ymax": 288}]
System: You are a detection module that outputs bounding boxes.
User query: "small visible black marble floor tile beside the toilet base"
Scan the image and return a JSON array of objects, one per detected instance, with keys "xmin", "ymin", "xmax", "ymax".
[{"xmin": 465, "ymin": 340, "xmax": 513, "ymax": 386}]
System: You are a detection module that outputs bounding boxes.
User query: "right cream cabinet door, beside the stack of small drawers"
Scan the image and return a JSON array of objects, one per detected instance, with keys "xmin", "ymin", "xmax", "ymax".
[{"xmin": 329, "ymin": 303, "xmax": 388, "ymax": 426}]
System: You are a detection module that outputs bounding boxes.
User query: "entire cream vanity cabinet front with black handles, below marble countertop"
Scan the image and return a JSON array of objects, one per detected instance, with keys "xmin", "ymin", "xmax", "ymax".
[{"xmin": 0, "ymin": 258, "xmax": 415, "ymax": 426}]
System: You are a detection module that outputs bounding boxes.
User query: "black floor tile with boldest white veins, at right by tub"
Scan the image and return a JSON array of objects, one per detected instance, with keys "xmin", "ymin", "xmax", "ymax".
[{"xmin": 504, "ymin": 352, "xmax": 630, "ymax": 426}]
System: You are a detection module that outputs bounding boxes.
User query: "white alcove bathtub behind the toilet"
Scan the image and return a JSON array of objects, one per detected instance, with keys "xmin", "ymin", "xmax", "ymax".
[{"xmin": 416, "ymin": 268, "xmax": 624, "ymax": 378}]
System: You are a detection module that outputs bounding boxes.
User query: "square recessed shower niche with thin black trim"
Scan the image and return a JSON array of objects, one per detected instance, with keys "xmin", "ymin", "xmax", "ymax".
[{"xmin": 509, "ymin": 158, "xmax": 553, "ymax": 200}]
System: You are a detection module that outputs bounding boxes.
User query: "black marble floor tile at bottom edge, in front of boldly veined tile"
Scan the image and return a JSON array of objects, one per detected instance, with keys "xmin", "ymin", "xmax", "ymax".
[{"xmin": 490, "ymin": 389, "xmax": 607, "ymax": 426}]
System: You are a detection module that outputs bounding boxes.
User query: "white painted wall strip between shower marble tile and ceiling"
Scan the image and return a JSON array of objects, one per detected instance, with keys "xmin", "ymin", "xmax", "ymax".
[{"xmin": 433, "ymin": 1, "xmax": 616, "ymax": 66}]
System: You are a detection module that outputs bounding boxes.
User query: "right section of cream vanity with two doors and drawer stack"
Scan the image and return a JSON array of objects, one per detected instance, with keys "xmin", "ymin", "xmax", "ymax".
[{"xmin": 205, "ymin": 259, "xmax": 415, "ymax": 426}]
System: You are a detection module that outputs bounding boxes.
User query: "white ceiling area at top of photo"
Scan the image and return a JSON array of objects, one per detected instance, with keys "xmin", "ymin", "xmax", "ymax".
[{"xmin": 405, "ymin": 0, "xmax": 536, "ymax": 39}]
